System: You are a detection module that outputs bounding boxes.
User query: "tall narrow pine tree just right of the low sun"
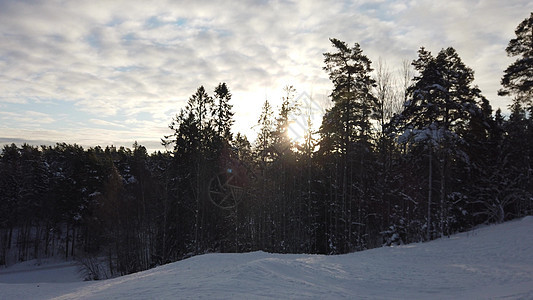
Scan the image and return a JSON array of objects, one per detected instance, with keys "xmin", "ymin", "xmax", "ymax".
[{"xmin": 320, "ymin": 39, "xmax": 379, "ymax": 253}]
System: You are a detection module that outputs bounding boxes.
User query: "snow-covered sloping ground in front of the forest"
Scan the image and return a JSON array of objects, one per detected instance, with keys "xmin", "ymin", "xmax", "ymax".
[{"xmin": 0, "ymin": 216, "xmax": 533, "ymax": 299}]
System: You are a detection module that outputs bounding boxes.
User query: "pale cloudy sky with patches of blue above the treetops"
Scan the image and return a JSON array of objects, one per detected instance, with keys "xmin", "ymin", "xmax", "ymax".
[{"xmin": 0, "ymin": 0, "xmax": 532, "ymax": 151}]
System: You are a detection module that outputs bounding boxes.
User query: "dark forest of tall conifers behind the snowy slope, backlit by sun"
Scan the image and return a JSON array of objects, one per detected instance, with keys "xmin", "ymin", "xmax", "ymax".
[{"xmin": 0, "ymin": 13, "xmax": 533, "ymax": 279}]
